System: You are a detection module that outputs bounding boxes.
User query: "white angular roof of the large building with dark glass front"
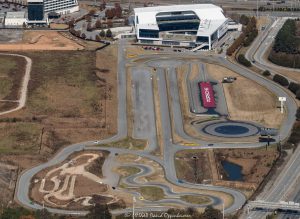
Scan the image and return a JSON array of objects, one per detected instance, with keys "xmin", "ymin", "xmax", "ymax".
[{"xmin": 134, "ymin": 4, "xmax": 227, "ymax": 35}]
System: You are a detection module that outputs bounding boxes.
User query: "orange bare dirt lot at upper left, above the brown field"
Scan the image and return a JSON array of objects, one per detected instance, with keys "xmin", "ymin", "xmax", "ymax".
[{"xmin": 0, "ymin": 31, "xmax": 83, "ymax": 51}]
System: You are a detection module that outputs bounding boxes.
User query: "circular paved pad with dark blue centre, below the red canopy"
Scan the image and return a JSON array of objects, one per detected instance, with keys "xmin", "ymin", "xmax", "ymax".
[{"xmin": 203, "ymin": 122, "xmax": 260, "ymax": 138}]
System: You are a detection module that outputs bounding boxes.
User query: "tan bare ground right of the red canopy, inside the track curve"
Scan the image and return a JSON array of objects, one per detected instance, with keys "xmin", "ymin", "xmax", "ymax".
[{"xmin": 207, "ymin": 64, "xmax": 284, "ymax": 128}]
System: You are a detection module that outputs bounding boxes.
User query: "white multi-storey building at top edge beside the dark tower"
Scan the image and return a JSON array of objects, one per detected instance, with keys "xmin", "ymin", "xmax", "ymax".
[{"xmin": 44, "ymin": 0, "xmax": 79, "ymax": 14}]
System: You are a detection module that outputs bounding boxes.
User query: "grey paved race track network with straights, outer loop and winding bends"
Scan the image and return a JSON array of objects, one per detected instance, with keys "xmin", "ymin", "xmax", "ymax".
[{"xmin": 15, "ymin": 40, "xmax": 296, "ymax": 215}]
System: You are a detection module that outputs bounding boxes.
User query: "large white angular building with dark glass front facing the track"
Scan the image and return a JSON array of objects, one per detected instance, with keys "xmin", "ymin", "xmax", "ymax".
[{"xmin": 134, "ymin": 4, "xmax": 228, "ymax": 49}]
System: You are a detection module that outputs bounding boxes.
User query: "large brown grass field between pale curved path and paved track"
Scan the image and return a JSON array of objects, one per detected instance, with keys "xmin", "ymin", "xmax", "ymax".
[{"xmin": 0, "ymin": 48, "xmax": 116, "ymax": 154}]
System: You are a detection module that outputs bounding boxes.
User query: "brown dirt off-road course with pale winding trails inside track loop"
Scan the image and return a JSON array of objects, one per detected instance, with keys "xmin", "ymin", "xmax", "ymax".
[{"xmin": 30, "ymin": 151, "xmax": 125, "ymax": 209}]
